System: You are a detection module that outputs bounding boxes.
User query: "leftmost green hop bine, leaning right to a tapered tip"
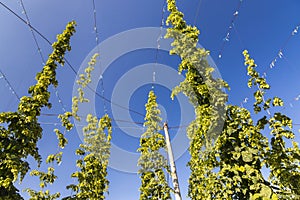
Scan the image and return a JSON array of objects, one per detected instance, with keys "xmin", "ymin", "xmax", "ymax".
[{"xmin": 0, "ymin": 19, "xmax": 75, "ymax": 199}]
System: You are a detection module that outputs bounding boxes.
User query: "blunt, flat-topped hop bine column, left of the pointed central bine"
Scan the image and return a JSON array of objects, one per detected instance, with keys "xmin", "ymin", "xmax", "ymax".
[{"xmin": 67, "ymin": 115, "xmax": 112, "ymax": 199}]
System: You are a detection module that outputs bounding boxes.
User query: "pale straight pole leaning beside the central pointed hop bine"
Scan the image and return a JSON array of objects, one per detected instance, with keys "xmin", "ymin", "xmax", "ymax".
[{"xmin": 164, "ymin": 123, "xmax": 181, "ymax": 200}]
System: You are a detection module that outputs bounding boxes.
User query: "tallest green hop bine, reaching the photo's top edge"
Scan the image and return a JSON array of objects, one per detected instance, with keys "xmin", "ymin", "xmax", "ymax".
[{"xmin": 165, "ymin": 0, "xmax": 228, "ymax": 199}]
